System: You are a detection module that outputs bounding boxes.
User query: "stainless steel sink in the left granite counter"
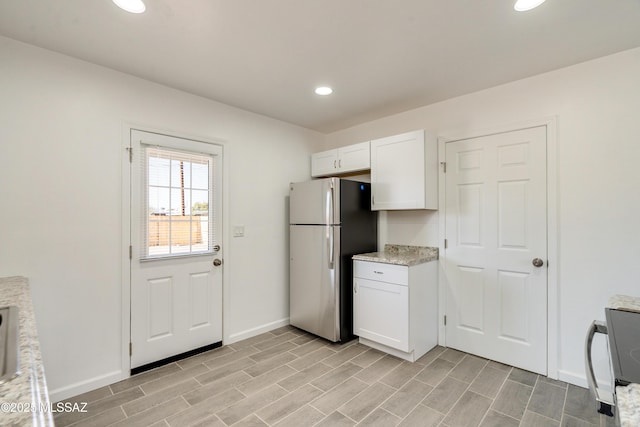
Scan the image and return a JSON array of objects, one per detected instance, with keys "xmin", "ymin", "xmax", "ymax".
[{"xmin": 0, "ymin": 306, "xmax": 20, "ymax": 383}]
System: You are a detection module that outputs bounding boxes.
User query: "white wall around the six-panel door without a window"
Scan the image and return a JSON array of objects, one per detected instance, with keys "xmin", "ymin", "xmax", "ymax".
[{"xmin": 325, "ymin": 49, "xmax": 640, "ymax": 386}]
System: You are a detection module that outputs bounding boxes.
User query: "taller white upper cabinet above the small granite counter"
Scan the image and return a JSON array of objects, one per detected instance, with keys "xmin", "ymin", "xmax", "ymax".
[{"xmin": 371, "ymin": 130, "xmax": 438, "ymax": 210}]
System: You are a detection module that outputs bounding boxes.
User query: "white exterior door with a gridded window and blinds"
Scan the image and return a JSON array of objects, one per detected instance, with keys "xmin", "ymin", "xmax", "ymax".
[{"xmin": 129, "ymin": 130, "xmax": 222, "ymax": 369}]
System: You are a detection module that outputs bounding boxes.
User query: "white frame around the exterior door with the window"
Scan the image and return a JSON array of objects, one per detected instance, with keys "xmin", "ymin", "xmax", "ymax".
[{"xmin": 120, "ymin": 122, "xmax": 230, "ymax": 379}]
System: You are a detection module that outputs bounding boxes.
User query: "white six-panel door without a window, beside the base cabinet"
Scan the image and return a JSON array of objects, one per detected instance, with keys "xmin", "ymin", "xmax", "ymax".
[{"xmin": 443, "ymin": 126, "xmax": 547, "ymax": 374}]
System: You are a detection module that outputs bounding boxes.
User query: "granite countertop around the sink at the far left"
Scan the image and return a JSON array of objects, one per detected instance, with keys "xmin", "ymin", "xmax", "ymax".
[{"xmin": 0, "ymin": 276, "xmax": 54, "ymax": 426}]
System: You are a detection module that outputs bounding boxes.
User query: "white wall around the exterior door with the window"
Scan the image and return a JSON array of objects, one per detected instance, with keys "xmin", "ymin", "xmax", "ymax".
[{"xmin": 0, "ymin": 37, "xmax": 323, "ymax": 400}]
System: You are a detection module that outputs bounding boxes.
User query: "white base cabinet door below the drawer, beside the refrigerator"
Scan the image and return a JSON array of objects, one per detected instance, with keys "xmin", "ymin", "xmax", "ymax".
[{"xmin": 353, "ymin": 277, "xmax": 412, "ymax": 352}]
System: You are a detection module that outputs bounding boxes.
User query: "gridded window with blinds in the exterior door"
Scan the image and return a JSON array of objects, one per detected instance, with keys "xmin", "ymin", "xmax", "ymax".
[{"xmin": 140, "ymin": 145, "xmax": 215, "ymax": 259}]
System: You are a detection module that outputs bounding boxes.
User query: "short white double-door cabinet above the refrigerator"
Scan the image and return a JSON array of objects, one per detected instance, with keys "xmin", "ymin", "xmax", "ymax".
[{"xmin": 311, "ymin": 141, "xmax": 371, "ymax": 177}]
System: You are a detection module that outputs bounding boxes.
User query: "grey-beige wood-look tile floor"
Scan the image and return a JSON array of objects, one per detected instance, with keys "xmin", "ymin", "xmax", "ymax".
[{"xmin": 55, "ymin": 326, "xmax": 614, "ymax": 427}]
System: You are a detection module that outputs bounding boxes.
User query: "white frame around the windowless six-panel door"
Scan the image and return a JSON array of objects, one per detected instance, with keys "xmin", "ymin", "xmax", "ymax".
[{"xmin": 438, "ymin": 116, "xmax": 559, "ymax": 379}]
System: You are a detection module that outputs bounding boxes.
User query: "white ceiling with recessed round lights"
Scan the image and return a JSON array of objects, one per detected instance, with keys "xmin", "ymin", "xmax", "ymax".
[{"xmin": 0, "ymin": 0, "xmax": 640, "ymax": 132}]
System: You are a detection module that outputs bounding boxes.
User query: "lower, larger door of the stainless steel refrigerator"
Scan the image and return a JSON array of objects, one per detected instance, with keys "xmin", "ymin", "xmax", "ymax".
[{"xmin": 289, "ymin": 225, "xmax": 340, "ymax": 341}]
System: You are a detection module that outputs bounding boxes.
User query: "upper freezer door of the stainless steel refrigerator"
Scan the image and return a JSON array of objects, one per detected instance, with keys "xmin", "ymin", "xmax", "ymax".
[{"xmin": 289, "ymin": 178, "xmax": 340, "ymax": 225}]
